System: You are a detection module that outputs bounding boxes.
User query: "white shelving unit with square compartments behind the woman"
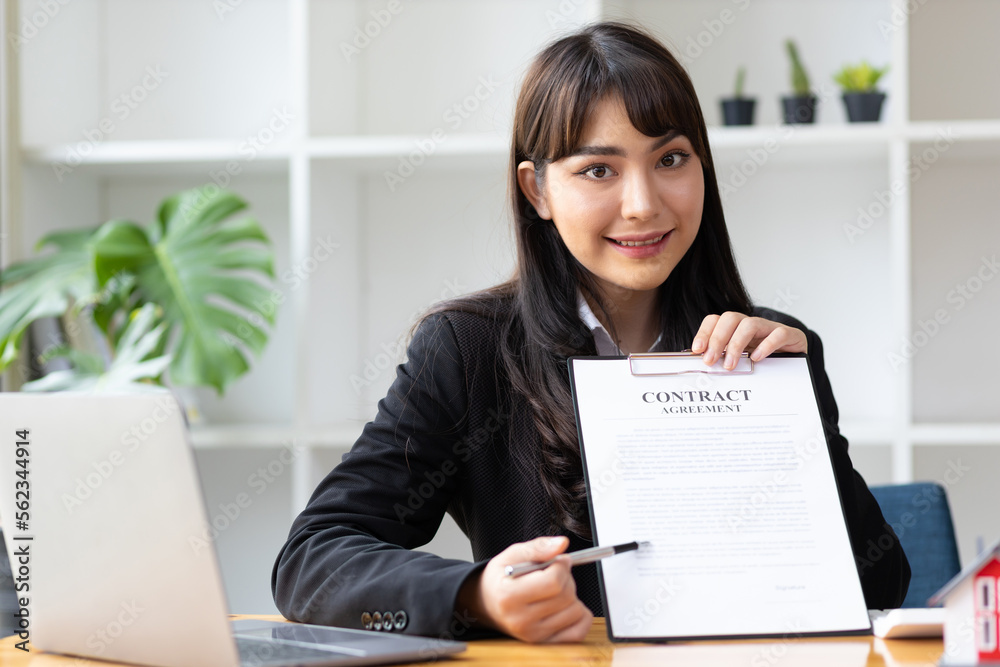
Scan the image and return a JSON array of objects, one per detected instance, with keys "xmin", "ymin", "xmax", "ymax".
[{"xmin": 0, "ymin": 0, "xmax": 1000, "ymax": 609}]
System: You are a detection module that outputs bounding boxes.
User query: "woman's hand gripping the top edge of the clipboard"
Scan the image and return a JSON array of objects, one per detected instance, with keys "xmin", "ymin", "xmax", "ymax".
[{"xmin": 691, "ymin": 312, "xmax": 809, "ymax": 370}]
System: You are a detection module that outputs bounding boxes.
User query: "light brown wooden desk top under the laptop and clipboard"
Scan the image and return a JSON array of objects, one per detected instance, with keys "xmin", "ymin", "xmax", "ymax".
[{"xmin": 0, "ymin": 616, "xmax": 942, "ymax": 667}]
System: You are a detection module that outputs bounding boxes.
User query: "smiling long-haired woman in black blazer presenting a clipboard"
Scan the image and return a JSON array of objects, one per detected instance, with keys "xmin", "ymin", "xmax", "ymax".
[{"xmin": 272, "ymin": 23, "xmax": 909, "ymax": 642}]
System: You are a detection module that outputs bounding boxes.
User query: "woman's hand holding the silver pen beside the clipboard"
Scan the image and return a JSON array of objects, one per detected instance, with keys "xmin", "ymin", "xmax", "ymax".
[{"xmin": 458, "ymin": 537, "xmax": 594, "ymax": 643}]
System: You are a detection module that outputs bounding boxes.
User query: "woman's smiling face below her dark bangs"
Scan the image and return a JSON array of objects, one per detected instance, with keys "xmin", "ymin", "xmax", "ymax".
[{"xmin": 518, "ymin": 98, "xmax": 705, "ymax": 294}]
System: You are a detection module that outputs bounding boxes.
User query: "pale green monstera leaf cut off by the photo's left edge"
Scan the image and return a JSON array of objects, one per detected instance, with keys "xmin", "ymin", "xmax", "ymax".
[{"xmin": 0, "ymin": 229, "xmax": 96, "ymax": 371}]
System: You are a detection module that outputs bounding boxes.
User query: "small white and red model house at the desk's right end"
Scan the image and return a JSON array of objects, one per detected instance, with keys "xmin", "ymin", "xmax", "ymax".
[{"xmin": 929, "ymin": 541, "xmax": 1000, "ymax": 664}]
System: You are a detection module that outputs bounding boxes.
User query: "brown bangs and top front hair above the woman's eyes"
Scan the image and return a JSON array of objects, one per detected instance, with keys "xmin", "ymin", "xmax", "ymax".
[{"xmin": 515, "ymin": 25, "xmax": 706, "ymax": 162}]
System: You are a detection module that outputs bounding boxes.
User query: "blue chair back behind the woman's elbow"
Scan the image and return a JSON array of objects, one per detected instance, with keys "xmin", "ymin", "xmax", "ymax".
[{"xmin": 871, "ymin": 482, "xmax": 961, "ymax": 607}]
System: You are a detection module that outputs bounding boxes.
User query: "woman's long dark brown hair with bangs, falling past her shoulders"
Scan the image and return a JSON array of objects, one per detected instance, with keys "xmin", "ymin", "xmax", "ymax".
[{"xmin": 426, "ymin": 22, "xmax": 751, "ymax": 537}]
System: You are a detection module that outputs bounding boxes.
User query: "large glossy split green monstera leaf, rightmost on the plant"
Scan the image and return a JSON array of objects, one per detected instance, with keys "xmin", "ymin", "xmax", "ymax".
[{"xmin": 91, "ymin": 188, "xmax": 276, "ymax": 394}]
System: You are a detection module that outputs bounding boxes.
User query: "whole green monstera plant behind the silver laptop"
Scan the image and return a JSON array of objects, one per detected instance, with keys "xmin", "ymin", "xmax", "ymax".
[{"xmin": 0, "ymin": 186, "xmax": 276, "ymax": 394}]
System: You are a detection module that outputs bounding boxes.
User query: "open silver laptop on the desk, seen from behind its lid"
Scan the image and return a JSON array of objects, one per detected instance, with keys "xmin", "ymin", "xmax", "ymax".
[{"xmin": 0, "ymin": 391, "xmax": 465, "ymax": 667}]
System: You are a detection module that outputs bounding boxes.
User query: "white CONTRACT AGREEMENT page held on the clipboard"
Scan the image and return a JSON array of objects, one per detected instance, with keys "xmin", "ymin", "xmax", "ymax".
[{"xmin": 570, "ymin": 355, "xmax": 871, "ymax": 641}]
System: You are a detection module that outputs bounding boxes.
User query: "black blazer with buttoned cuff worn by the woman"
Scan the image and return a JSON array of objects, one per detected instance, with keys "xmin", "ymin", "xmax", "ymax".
[{"xmin": 271, "ymin": 302, "xmax": 910, "ymax": 639}]
